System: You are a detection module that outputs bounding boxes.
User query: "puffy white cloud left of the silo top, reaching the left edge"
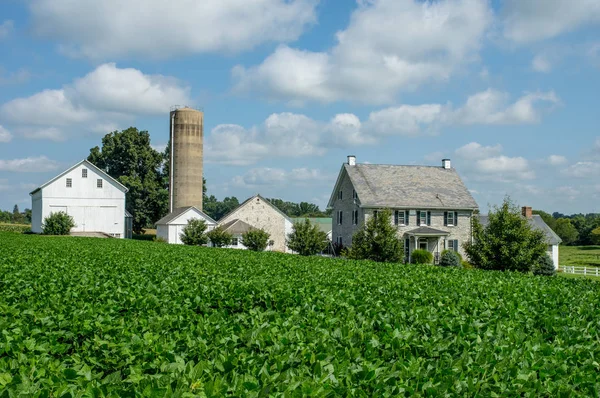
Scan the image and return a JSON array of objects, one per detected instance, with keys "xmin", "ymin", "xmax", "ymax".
[{"xmin": 0, "ymin": 63, "xmax": 191, "ymax": 141}]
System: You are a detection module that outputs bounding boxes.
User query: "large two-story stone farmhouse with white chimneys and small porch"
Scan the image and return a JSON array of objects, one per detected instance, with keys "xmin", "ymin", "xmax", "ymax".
[{"xmin": 327, "ymin": 156, "xmax": 478, "ymax": 262}]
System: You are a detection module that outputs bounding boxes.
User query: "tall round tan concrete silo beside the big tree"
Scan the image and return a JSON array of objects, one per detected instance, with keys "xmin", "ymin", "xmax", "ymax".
[{"xmin": 169, "ymin": 107, "xmax": 204, "ymax": 212}]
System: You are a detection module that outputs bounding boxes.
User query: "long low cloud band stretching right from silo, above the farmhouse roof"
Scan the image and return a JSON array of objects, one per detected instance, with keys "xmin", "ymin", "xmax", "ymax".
[{"xmin": 205, "ymin": 90, "xmax": 558, "ymax": 165}]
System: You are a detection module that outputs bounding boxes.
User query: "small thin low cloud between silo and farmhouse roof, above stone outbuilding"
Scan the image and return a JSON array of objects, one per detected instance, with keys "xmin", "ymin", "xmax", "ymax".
[{"xmin": 232, "ymin": 167, "xmax": 327, "ymax": 187}]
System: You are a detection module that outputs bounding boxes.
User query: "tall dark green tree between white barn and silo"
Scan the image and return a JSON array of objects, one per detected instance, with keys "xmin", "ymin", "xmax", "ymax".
[{"xmin": 88, "ymin": 127, "xmax": 169, "ymax": 234}]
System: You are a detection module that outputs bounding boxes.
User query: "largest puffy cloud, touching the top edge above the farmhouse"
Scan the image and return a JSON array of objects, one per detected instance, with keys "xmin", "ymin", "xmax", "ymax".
[{"xmin": 233, "ymin": 0, "xmax": 492, "ymax": 103}]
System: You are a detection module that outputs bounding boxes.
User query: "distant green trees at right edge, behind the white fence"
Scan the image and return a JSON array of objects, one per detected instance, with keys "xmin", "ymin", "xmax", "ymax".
[{"xmin": 533, "ymin": 210, "xmax": 600, "ymax": 246}]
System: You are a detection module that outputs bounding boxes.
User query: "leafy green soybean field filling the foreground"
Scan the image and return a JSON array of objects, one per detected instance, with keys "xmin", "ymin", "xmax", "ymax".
[{"xmin": 0, "ymin": 232, "xmax": 600, "ymax": 397}]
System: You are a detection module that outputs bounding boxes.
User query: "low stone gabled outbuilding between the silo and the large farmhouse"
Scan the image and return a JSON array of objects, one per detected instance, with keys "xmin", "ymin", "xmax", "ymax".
[{"xmin": 219, "ymin": 195, "xmax": 293, "ymax": 253}]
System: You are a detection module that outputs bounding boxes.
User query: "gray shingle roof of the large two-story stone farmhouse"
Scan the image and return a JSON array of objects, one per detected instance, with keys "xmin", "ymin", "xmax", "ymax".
[{"xmin": 344, "ymin": 164, "xmax": 478, "ymax": 209}]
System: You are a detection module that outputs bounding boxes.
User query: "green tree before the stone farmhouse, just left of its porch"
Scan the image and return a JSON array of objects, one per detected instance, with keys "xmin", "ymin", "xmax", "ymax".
[{"xmin": 348, "ymin": 210, "xmax": 404, "ymax": 262}]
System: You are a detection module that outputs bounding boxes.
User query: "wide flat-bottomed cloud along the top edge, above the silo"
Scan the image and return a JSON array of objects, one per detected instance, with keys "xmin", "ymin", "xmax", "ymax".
[{"xmin": 30, "ymin": 0, "xmax": 317, "ymax": 59}]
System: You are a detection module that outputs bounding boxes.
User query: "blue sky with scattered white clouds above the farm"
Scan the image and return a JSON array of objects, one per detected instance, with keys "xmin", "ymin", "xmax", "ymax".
[{"xmin": 0, "ymin": 0, "xmax": 600, "ymax": 214}]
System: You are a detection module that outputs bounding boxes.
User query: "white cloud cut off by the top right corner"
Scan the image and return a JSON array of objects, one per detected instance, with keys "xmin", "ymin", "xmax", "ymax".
[{"xmin": 503, "ymin": 0, "xmax": 600, "ymax": 44}]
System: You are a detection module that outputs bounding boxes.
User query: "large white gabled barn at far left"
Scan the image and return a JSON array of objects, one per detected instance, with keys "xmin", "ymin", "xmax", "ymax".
[{"xmin": 30, "ymin": 160, "xmax": 127, "ymax": 238}]
